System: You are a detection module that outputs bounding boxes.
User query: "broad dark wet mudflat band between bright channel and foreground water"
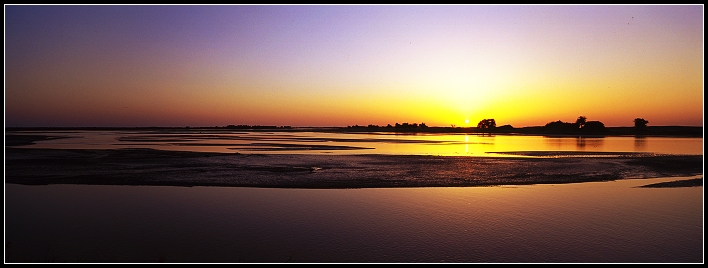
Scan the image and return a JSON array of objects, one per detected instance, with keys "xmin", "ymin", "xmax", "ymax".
[{"xmin": 5, "ymin": 147, "xmax": 703, "ymax": 189}]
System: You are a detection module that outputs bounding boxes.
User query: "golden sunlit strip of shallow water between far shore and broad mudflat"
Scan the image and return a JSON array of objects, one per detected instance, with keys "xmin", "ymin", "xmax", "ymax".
[{"xmin": 4, "ymin": 130, "xmax": 703, "ymax": 156}]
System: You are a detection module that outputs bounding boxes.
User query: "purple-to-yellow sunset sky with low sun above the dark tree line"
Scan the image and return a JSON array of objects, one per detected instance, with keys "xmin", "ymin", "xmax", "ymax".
[{"xmin": 5, "ymin": 5, "xmax": 704, "ymax": 127}]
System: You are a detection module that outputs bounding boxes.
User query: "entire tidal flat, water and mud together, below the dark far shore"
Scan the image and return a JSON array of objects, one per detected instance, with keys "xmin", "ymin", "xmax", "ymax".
[{"xmin": 5, "ymin": 131, "xmax": 703, "ymax": 263}]
